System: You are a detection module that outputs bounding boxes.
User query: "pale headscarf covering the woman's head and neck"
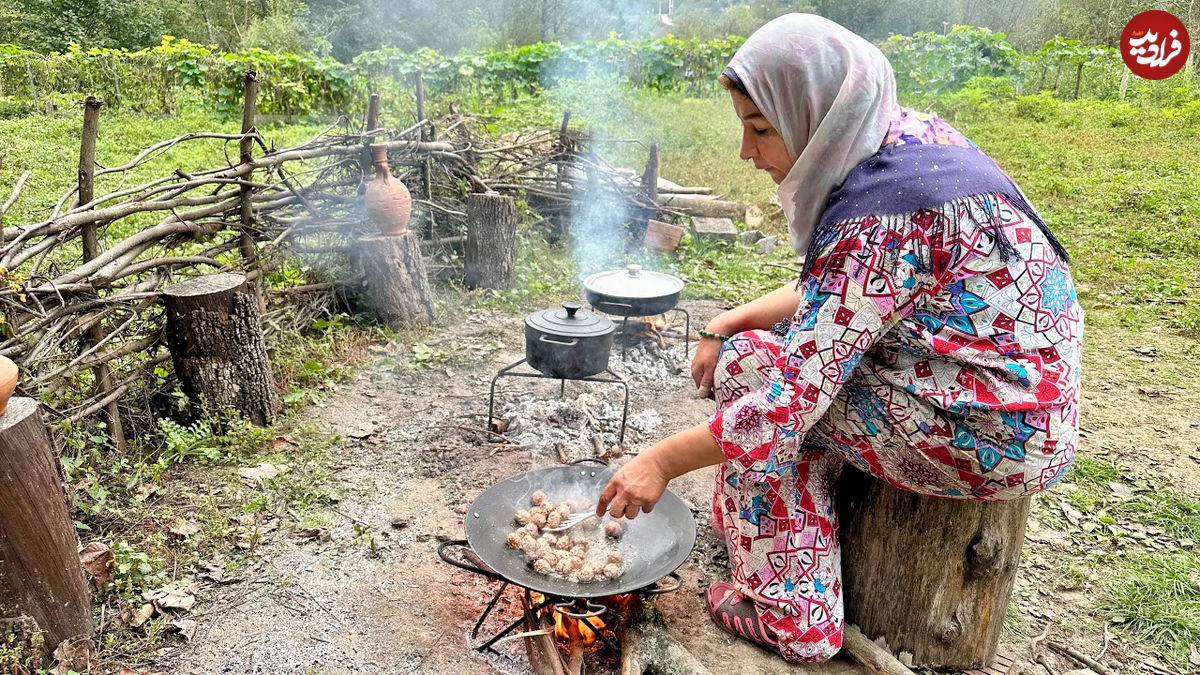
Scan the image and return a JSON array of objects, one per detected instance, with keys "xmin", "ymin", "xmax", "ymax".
[{"xmin": 730, "ymin": 14, "xmax": 896, "ymax": 256}]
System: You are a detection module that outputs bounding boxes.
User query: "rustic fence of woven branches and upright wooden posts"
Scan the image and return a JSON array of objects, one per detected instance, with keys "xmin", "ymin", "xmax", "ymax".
[{"xmin": 0, "ymin": 72, "xmax": 672, "ymax": 447}]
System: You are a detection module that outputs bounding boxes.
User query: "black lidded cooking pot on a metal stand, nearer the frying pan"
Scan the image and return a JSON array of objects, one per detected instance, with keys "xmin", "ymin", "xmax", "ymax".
[{"xmin": 526, "ymin": 303, "xmax": 616, "ymax": 380}]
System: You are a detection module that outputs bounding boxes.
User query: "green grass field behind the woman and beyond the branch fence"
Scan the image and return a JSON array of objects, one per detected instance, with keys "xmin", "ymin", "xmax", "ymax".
[{"xmin": 0, "ymin": 86, "xmax": 1200, "ymax": 668}]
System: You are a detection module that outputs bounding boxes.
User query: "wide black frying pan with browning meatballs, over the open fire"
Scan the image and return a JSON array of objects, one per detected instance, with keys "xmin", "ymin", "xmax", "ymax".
[{"xmin": 438, "ymin": 460, "xmax": 696, "ymax": 598}]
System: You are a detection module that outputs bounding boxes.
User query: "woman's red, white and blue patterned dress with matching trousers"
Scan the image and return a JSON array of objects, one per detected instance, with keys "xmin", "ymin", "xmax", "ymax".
[{"xmin": 709, "ymin": 112, "xmax": 1084, "ymax": 662}]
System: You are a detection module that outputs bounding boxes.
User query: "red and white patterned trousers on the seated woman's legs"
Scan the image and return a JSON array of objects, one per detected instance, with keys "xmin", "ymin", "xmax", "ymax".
[{"xmin": 713, "ymin": 330, "xmax": 1051, "ymax": 663}]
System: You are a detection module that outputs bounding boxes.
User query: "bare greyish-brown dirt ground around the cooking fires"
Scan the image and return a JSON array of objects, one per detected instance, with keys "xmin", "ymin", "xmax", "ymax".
[{"xmin": 158, "ymin": 301, "xmax": 1200, "ymax": 675}]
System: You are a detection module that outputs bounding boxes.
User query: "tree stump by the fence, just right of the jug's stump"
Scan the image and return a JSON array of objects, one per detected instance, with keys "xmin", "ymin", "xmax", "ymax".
[{"xmin": 463, "ymin": 193, "xmax": 517, "ymax": 291}]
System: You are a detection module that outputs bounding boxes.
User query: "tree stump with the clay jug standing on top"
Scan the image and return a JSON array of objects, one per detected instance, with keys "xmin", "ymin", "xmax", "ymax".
[{"xmin": 353, "ymin": 232, "xmax": 433, "ymax": 328}]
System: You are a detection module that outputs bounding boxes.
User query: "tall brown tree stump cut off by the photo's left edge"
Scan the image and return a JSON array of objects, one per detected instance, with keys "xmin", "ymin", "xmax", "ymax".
[{"xmin": 0, "ymin": 396, "xmax": 91, "ymax": 661}]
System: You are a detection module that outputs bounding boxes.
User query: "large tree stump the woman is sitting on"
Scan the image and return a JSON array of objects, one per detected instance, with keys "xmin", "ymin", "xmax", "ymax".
[{"xmin": 838, "ymin": 467, "xmax": 1030, "ymax": 670}]
